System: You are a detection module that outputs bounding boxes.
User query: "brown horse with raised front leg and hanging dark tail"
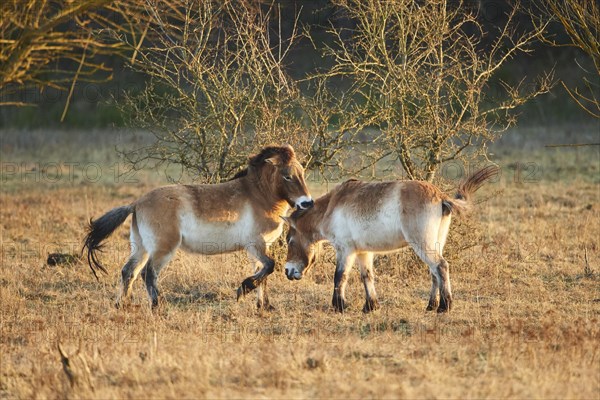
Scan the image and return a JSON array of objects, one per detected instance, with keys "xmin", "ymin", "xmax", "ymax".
[{"xmin": 83, "ymin": 146, "xmax": 313, "ymax": 308}]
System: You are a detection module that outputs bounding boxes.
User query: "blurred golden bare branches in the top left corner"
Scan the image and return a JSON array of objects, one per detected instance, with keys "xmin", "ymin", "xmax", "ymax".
[{"xmin": 0, "ymin": 0, "xmax": 146, "ymax": 114}]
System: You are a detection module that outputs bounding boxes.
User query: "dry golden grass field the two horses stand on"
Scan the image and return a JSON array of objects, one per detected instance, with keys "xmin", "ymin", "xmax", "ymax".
[{"xmin": 0, "ymin": 124, "xmax": 600, "ymax": 399}]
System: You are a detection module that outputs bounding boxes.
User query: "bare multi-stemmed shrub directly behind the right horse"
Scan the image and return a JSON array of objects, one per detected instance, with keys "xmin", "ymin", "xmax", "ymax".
[{"xmin": 324, "ymin": 0, "xmax": 553, "ymax": 181}]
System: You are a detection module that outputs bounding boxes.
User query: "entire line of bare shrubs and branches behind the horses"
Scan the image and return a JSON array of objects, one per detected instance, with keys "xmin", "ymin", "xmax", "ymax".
[{"xmin": 0, "ymin": 0, "xmax": 600, "ymax": 182}]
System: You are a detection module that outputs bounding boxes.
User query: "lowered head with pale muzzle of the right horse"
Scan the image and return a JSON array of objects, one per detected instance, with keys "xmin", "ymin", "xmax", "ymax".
[{"xmin": 282, "ymin": 210, "xmax": 318, "ymax": 280}]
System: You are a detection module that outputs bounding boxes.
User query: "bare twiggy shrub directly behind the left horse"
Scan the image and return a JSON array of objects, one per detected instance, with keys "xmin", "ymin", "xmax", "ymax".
[{"xmin": 115, "ymin": 0, "xmax": 302, "ymax": 182}]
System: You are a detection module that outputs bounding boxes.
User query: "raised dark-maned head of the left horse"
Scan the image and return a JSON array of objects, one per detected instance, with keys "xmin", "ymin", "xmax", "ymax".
[{"xmin": 250, "ymin": 145, "xmax": 314, "ymax": 209}]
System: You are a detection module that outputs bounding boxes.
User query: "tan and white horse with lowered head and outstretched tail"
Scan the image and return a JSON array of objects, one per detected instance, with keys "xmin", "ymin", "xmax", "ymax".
[{"xmin": 284, "ymin": 166, "xmax": 499, "ymax": 313}]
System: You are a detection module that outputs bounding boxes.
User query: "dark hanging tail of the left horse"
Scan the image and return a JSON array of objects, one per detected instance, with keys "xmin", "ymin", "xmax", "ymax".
[{"xmin": 81, "ymin": 204, "xmax": 134, "ymax": 279}]
